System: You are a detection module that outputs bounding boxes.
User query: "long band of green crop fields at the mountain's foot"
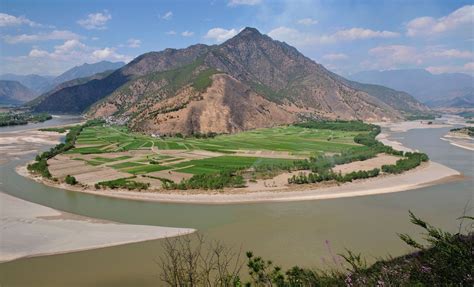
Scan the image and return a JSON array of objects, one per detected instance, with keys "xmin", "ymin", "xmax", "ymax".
[{"xmin": 68, "ymin": 126, "xmax": 360, "ymax": 156}]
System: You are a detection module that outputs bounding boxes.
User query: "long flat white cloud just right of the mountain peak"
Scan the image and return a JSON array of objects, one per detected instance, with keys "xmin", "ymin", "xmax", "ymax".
[{"xmin": 268, "ymin": 26, "xmax": 400, "ymax": 46}]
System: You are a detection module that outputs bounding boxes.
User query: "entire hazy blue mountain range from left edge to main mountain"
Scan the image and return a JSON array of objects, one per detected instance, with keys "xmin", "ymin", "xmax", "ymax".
[{"xmin": 0, "ymin": 61, "xmax": 125, "ymax": 104}]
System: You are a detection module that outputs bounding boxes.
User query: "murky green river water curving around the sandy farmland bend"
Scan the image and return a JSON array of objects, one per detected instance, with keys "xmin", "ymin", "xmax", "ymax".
[{"xmin": 0, "ymin": 120, "xmax": 474, "ymax": 286}]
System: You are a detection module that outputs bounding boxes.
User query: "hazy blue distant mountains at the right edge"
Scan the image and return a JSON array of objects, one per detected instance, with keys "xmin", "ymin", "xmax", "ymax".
[{"xmin": 350, "ymin": 69, "xmax": 474, "ymax": 106}]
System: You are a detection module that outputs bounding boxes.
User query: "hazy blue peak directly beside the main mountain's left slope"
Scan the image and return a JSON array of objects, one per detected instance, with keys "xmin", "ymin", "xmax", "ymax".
[{"xmin": 52, "ymin": 61, "xmax": 125, "ymax": 86}]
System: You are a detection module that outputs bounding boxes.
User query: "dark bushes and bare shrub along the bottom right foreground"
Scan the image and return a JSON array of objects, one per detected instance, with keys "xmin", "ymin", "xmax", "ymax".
[{"xmin": 159, "ymin": 212, "xmax": 474, "ymax": 287}]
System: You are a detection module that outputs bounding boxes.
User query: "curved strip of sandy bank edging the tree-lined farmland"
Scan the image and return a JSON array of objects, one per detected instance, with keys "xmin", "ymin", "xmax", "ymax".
[{"xmin": 17, "ymin": 161, "xmax": 463, "ymax": 204}]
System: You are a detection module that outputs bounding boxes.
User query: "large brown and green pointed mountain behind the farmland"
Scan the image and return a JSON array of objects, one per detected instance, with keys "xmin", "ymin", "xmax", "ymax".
[{"xmin": 29, "ymin": 28, "xmax": 428, "ymax": 134}]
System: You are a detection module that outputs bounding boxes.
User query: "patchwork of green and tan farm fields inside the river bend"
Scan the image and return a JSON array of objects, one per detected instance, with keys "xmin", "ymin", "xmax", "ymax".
[{"xmin": 48, "ymin": 125, "xmax": 392, "ymax": 188}]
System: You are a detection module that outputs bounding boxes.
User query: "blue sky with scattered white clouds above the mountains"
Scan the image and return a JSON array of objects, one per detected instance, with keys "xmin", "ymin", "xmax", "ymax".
[{"xmin": 0, "ymin": 0, "xmax": 474, "ymax": 76}]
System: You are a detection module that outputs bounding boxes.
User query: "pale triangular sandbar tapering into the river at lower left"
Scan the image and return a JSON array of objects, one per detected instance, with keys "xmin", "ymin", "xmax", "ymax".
[{"xmin": 0, "ymin": 192, "xmax": 195, "ymax": 262}]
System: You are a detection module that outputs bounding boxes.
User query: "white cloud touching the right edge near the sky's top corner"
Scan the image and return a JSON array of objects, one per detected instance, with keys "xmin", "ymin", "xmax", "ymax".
[{"xmin": 407, "ymin": 5, "xmax": 474, "ymax": 37}]
